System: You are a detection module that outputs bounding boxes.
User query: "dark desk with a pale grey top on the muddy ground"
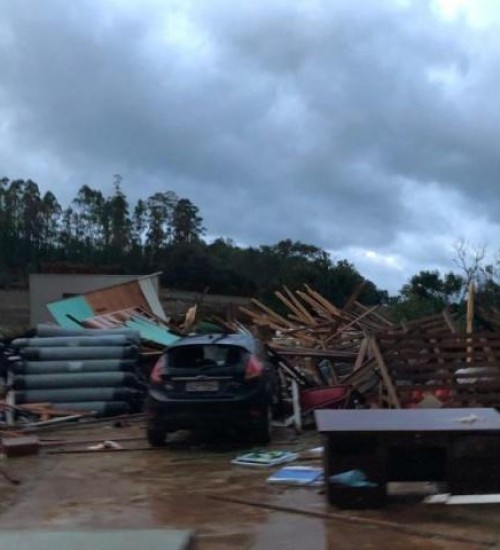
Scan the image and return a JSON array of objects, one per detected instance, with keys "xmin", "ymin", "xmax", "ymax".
[{"xmin": 315, "ymin": 408, "xmax": 500, "ymax": 507}]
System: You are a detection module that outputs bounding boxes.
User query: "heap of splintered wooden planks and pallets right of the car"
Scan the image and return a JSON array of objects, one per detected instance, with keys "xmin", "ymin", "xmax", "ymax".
[{"xmin": 226, "ymin": 285, "xmax": 500, "ymax": 408}]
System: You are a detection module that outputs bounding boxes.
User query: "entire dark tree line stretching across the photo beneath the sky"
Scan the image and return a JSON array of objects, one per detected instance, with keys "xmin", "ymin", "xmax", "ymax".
[{"xmin": 0, "ymin": 175, "xmax": 500, "ymax": 320}]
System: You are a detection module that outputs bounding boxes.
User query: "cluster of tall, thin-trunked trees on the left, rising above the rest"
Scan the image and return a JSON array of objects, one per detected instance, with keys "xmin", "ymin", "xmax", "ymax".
[{"xmin": 0, "ymin": 175, "xmax": 204, "ymax": 270}]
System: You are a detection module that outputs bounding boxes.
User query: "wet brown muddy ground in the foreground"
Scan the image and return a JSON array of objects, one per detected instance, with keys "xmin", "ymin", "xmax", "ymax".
[{"xmin": 0, "ymin": 424, "xmax": 500, "ymax": 550}]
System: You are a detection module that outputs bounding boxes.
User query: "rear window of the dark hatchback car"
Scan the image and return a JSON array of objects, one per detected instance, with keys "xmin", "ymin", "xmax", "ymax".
[{"xmin": 168, "ymin": 344, "xmax": 248, "ymax": 369}]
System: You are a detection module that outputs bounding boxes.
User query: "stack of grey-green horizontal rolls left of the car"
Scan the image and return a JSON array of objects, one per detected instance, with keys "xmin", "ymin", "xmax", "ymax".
[{"xmin": 10, "ymin": 325, "xmax": 144, "ymax": 416}]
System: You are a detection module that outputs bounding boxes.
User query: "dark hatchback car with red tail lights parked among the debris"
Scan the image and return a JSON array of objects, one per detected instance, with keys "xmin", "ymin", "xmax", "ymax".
[{"xmin": 147, "ymin": 333, "xmax": 276, "ymax": 446}]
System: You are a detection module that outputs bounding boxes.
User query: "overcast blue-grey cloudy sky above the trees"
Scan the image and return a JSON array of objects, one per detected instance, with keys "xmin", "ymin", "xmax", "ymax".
[{"xmin": 0, "ymin": 0, "xmax": 500, "ymax": 291}]
